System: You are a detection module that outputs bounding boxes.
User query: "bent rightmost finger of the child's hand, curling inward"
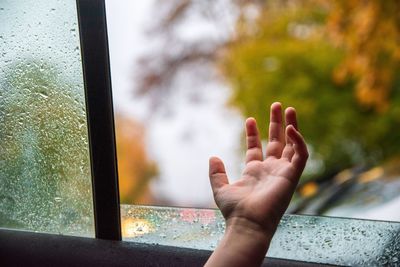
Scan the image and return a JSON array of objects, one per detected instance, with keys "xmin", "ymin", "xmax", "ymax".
[{"xmin": 287, "ymin": 125, "xmax": 308, "ymax": 173}]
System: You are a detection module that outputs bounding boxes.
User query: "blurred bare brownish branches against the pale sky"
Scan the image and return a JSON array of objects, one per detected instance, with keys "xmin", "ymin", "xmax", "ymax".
[{"xmin": 135, "ymin": 0, "xmax": 236, "ymax": 110}]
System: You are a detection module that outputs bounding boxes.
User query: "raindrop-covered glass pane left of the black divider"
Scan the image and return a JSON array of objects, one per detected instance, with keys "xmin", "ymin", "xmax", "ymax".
[{"xmin": 0, "ymin": 0, "xmax": 94, "ymax": 236}]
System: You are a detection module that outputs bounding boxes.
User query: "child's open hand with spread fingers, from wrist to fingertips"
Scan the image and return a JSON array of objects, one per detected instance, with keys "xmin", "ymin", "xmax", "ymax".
[{"xmin": 210, "ymin": 104, "xmax": 308, "ymax": 231}]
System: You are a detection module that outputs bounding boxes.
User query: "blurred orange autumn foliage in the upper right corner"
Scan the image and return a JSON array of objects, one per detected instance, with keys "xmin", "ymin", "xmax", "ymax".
[{"xmin": 327, "ymin": 0, "xmax": 400, "ymax": 112}]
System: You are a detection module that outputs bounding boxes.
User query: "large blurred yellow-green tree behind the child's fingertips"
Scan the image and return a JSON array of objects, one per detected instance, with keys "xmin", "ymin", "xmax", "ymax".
[{"xmin": 221, "ymin": 1, "xmax": 400, "ymax": 180}]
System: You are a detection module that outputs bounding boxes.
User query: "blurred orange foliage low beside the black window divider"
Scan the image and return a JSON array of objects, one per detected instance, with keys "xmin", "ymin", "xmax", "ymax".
[{"xmin": 115, "ymin": 114, "xmax": 158, "ymax": 204}]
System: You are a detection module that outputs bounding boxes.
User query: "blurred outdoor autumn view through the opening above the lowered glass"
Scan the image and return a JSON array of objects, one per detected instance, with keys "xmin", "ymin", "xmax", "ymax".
[{"xmin": 107, "ymin": 0, "xmax": 400, "ymax": 220}]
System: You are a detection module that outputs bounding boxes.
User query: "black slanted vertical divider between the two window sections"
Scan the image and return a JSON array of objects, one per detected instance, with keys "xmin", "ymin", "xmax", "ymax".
[{"xmin": 76, "ymin": 0, "xmax": 121, "ymax": 240}]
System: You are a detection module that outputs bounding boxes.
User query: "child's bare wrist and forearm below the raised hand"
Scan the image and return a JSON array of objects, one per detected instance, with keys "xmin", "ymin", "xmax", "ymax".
[{"xmin": 205, "ymin": 218, "xmax": 275, "ymax": 267}]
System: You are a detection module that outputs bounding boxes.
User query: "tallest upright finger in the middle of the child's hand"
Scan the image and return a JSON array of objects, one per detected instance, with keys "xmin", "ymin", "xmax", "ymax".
[{"xmin": 266, "ymin": 102, "xmax": 285, "ymax": 158}]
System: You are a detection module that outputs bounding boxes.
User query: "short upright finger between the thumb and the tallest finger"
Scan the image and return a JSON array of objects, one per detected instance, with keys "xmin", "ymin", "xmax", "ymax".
[{"xmin": 246, "ymin": 118, "xmax": 263, "ymax": 163}]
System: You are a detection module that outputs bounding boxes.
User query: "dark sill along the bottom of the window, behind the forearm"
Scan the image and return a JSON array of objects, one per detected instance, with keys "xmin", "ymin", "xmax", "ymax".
[{"xmin": 0, "ymin": 229, "xmax": 326, "ymax": 266}]
